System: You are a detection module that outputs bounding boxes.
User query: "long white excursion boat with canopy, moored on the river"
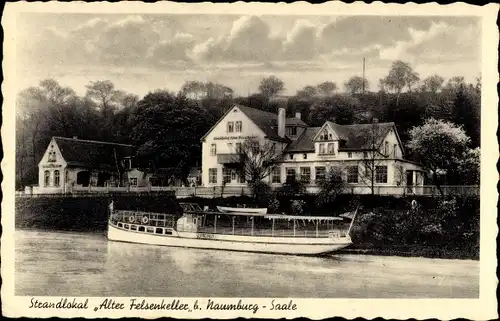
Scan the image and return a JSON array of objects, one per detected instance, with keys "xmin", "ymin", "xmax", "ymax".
[{"xmin": 108, "ymin": 203, "xmax": 357, "ymax": 255}]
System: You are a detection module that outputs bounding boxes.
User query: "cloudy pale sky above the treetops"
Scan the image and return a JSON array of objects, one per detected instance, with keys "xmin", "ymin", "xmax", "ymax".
[{"xmin": 15, "ymin": 13, "xmax": 481, "ymax": 97}]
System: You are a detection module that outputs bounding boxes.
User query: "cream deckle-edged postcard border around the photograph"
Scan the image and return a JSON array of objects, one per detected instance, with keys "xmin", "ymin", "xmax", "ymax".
[{"xmin": 1, "ymin": 2, "xmax": 499, "ymax": 320}]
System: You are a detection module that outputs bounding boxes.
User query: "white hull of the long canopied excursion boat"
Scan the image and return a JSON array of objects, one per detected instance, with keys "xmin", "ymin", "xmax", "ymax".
[{"xmin": 108, "ymin": 224, "xmax": 351, "ymax": 255}]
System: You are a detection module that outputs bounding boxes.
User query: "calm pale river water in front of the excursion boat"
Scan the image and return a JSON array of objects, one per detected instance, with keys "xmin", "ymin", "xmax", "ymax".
[{"xmin": 15, "ymin": 230, "xmax": 479, "ymax": 298}]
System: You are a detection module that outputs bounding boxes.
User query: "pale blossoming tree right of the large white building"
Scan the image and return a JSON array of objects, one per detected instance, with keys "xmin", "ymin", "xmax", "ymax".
[{"xmin": 408, "ymin": 118, "xmax": 470, "ymax": 194}]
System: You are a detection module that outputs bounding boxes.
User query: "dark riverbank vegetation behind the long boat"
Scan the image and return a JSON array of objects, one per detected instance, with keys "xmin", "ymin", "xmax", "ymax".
[{"xmin": 15, "ymin": 194, "xmax": 479, "ymax": 260}]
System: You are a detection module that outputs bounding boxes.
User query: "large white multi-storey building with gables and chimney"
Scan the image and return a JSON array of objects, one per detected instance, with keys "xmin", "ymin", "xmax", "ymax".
[{"xmin": 202, "ymin": 105, "xmax": 425, "ymax": 194}]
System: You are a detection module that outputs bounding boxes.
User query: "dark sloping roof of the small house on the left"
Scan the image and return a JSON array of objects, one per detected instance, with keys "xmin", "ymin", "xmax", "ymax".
[{"xmin": 54, "ymin": 137, "xmax": 134, "ymax": 168}]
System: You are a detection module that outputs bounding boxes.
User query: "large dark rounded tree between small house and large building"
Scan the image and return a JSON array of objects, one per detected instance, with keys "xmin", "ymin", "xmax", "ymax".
[{"xmin": 130, "ymin": 90, "xmax": 210, "ymax": 180}]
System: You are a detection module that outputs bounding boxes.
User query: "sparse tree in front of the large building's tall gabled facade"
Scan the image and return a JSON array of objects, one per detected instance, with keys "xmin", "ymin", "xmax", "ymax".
[{"xmin": 234, "ymin": 138, "xmax": 282, "ymax": 195}]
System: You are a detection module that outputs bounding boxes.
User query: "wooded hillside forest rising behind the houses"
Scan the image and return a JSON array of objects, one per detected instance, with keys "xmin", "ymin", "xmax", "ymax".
[{"xmin": 16, "ymin": 61, "xmax": 481, "ymax": 189}]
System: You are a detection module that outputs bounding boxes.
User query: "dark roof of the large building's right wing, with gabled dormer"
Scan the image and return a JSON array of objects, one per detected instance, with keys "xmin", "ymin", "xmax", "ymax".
[{"xmin": 285, "ymin": 121, "xmax": 394, "ymax": 153}]
